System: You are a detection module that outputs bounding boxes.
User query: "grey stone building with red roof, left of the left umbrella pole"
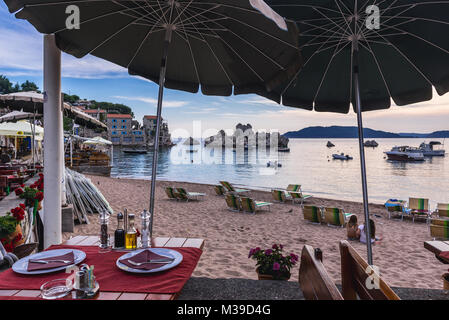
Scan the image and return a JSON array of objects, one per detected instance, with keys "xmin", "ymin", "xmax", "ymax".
[{"xmin": 106, "ymin": 113, "xmax": 146, "ymax": 146}]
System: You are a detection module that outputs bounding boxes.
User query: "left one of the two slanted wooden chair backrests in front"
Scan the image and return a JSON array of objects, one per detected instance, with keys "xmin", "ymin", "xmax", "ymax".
[{"xmin": 299, "ymin": 245, "xmax": 343, "ymax": 300}]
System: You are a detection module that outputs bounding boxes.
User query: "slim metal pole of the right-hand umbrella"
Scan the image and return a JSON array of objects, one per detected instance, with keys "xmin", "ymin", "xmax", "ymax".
[{"xmin": 353, "ymin": 45, "xmax": 373, "ymax": 265}]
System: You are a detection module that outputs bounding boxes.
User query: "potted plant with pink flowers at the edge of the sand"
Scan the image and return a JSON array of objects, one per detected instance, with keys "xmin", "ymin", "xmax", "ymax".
[{"xmin": 248, "ymin": 244, "xmax": 299, "ymax": 280}]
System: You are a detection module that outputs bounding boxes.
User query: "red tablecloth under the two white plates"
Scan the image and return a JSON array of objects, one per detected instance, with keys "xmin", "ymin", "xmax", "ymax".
[{"xmin": 0, "ymin": 245, "xmax": 202, "ymax": 294}]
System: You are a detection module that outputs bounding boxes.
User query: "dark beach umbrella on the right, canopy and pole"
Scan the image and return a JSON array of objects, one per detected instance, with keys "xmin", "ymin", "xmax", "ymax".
[{"xmin": 267, "ymin": 0, "xmax": 449, "ymax": 264}]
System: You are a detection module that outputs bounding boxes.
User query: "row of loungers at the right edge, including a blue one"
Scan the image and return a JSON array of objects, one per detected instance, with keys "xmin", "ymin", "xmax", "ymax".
[{"xmin": 385, "ymin": 198, "xmax": 449, "ymax": 223}]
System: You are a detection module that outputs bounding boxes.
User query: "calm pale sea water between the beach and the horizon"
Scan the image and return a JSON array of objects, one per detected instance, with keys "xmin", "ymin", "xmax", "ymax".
[{"xmin": 111, "ymin": 139, "xmax": 449, "ymax": 204}]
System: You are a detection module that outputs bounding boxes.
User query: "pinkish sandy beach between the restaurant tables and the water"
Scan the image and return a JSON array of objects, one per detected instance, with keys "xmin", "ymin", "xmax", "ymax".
[{"xmin": 64, "ymin": 176, "xmax": 447, "ymax": 289}]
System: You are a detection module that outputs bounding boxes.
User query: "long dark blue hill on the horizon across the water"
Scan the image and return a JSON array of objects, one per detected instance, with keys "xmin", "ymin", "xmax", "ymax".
[{"xmin": 283, "ymin": 126, "xmax": 449, "ymax": 139}]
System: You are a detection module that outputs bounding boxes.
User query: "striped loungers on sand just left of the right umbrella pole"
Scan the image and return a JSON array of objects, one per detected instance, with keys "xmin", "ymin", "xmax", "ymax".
[{"xmin": 302, "ymin": 206, "xmax": 353, "ymax": 227}]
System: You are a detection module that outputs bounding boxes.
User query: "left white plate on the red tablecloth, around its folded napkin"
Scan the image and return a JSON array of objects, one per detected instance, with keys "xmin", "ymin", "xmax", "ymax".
[{"xmin": 12, "ymin": 249, "xmax": 86, "ymax": 274}]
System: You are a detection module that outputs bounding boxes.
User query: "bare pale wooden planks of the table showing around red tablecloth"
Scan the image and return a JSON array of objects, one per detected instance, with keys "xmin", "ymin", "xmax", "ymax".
[{"xmin": 0, "ymin": 236, "xmax": 204, "ymax": 300}]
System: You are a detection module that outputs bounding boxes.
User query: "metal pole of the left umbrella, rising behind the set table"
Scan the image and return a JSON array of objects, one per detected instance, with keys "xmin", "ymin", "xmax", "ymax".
[{"xmin": 148, "ymin": 25, "xmax": 173, "ymax": 239}]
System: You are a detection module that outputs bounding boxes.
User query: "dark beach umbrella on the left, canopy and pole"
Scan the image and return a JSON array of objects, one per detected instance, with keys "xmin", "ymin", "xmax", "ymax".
[{"xmin": 5, "ymin": 0, "xmax": 302, "ymax": 235}]
